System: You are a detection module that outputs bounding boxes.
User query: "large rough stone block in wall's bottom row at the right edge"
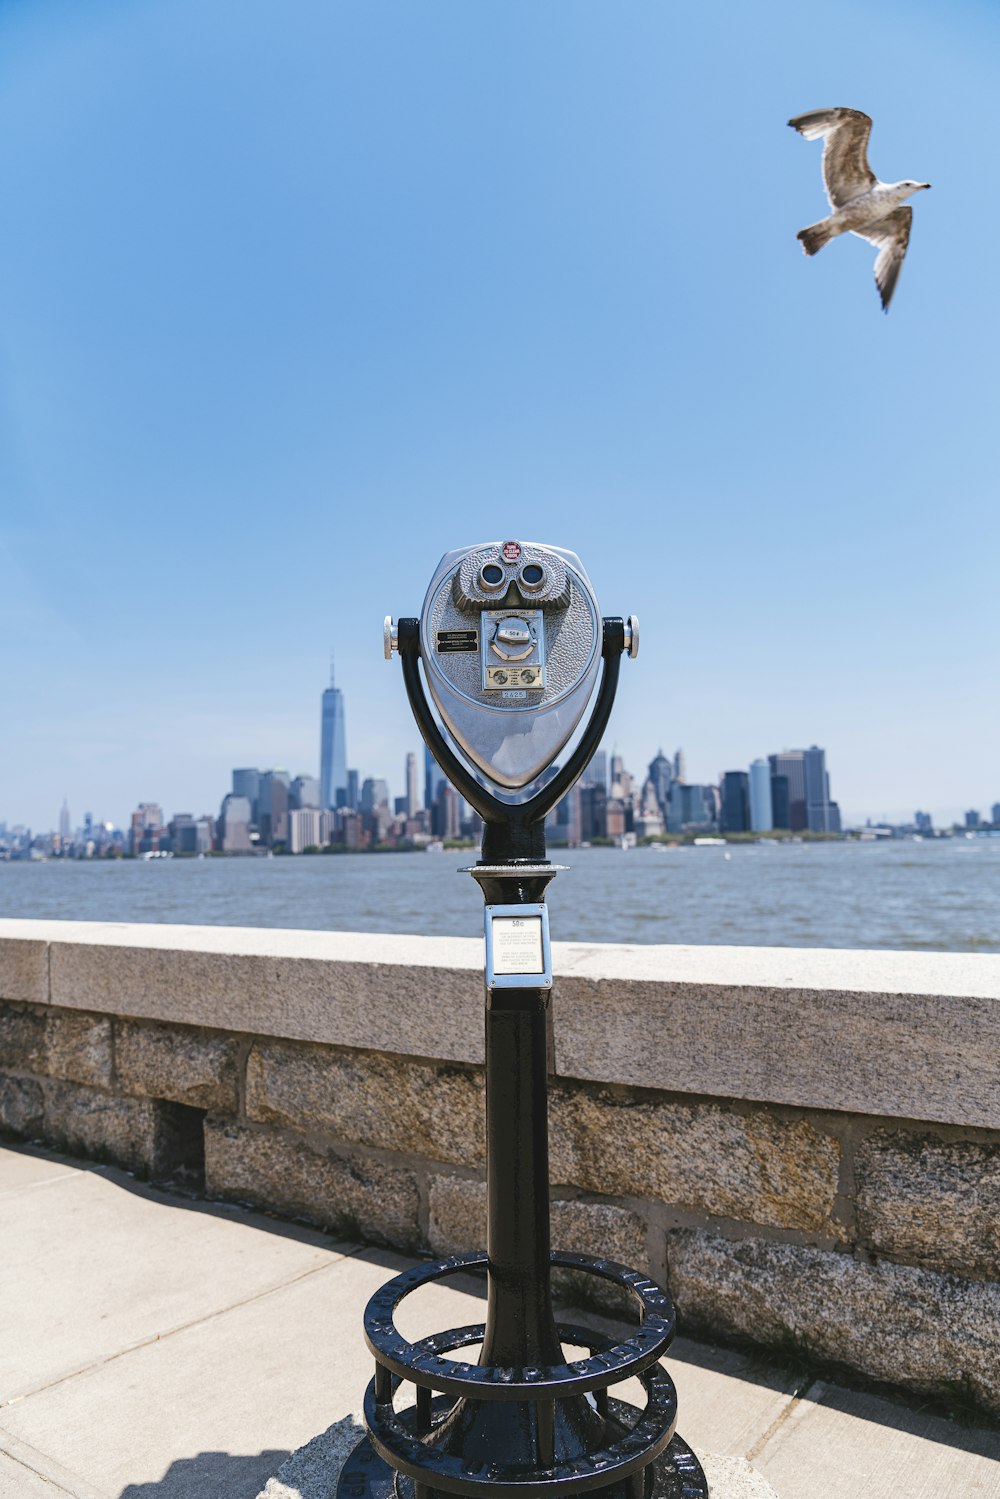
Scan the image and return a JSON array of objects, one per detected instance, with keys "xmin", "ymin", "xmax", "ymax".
[{"xmin": 667, "ymin": 1229, "xmax": 1000, "ymax": 1414}]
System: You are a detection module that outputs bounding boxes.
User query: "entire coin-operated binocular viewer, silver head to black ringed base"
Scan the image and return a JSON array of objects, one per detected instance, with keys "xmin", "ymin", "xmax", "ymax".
[{"xmin": 337, "ymin": 541, "xmax": 708, "ymax": 1499}]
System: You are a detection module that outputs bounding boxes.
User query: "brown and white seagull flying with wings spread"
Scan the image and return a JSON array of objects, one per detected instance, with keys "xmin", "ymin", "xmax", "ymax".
[{"xmin": 789, "ymin": 109, "xmax": 931, "ymax": 312}]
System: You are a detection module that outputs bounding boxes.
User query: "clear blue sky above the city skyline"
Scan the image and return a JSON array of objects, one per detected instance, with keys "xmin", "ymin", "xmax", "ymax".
[{"xmin": 0, "ymin": 0, "xmax": 1000, "ymax": 827}]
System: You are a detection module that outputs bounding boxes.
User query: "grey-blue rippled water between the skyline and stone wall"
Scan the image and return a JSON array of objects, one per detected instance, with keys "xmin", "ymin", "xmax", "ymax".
[{"xmin": 0, "ymin": 838, "xmax": 1000, "ymax": 952}]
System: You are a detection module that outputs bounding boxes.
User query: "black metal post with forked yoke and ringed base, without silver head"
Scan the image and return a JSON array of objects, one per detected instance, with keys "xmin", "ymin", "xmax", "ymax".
[{"xmin": 337, "ymin": 619, "xmax": 708, "ymax": 1499}]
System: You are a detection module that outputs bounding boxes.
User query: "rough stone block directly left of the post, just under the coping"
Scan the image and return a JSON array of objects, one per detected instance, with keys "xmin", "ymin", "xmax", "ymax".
[{"xmin": 246, "ymin": 1042, "xmax": 486, "ymax": 1165}]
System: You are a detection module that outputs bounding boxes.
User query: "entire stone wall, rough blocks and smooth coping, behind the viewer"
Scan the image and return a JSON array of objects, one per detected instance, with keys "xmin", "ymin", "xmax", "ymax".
[{"xmin": 0, "ymin": 922, "xmax": 1000, "ymax": 1414}]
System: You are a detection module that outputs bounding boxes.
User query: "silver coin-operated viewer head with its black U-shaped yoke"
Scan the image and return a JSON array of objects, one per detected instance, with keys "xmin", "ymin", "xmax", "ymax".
[{"xmin": 384, "ymin": 541, "xmax": 639, "ymax": 857}]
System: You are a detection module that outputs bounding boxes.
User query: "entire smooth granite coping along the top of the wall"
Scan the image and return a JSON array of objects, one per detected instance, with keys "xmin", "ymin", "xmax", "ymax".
[{"xmin": 0, "ymin": 920, "xmax": 1000, "ymax": 1129}]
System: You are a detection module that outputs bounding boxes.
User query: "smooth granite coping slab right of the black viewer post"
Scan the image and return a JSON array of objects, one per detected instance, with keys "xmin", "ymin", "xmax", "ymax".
[{"xmin": 553, "ymin": 943, "xmax": 1000, "ymax": 1129}]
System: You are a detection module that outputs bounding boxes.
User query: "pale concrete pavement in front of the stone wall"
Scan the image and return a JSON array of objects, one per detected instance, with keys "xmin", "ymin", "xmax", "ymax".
[{"xmin": 0, "ymin": 1148, "xmax": 1000, "ymax": 1499}]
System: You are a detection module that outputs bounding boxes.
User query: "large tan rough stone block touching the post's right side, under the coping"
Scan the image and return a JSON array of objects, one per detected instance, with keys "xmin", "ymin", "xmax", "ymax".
[{"xmin": 549, "ymin": 1087, "xmax": 840, "ymax": 1232}]
